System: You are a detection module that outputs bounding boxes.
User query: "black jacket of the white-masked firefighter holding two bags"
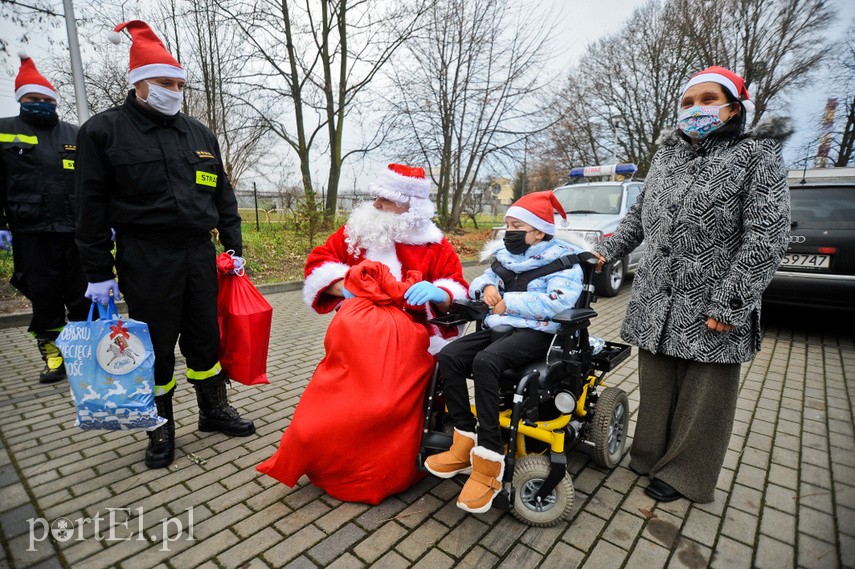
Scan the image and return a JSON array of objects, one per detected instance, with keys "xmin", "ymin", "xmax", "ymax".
[{"xmin": 75, "ymin": 90, "xmax": 243, "ymax": 282}]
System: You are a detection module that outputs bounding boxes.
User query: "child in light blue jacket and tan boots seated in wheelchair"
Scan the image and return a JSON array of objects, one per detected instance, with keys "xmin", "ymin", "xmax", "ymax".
[{"xmin": 424, "ymin": 191, "xmax": 583, "ymax": 513}]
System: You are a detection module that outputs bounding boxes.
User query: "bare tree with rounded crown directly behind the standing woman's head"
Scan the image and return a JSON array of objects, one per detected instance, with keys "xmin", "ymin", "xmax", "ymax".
[{"xmin": 548, "ymin": 0, "xmax": 698, "ymax": 173}]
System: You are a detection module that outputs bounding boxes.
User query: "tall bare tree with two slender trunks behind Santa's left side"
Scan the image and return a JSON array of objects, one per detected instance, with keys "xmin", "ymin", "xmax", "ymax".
[{"xmin": 211, "ymin": 0, "xmax": 429, "ymax": 217}]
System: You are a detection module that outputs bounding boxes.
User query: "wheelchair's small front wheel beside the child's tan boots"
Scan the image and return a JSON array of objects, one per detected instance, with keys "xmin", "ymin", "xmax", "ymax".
[{"xmin": 511, "ymin": 455, "xmax": 575, "ymax": 527}]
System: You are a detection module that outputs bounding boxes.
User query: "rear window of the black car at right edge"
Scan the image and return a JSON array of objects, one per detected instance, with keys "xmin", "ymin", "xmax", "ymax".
[{"xmin": 790, "ymin": 186, "xmax": 855, "ymax": 229}]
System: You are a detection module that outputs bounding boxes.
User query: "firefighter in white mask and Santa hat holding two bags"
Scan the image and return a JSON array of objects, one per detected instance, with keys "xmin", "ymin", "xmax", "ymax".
[{"xmin": 76, "ymin": 20, "xmax": 255, "ymax": 468}]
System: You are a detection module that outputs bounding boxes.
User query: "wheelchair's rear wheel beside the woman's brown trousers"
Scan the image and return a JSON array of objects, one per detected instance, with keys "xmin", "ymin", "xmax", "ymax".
[{"xmin": 591, "ymin": 387, "xmax": 629, "ymax": 468}]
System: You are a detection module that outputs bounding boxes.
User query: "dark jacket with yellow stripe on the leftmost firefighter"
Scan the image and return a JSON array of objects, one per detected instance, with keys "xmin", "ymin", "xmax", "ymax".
[{"xmin": 0, "ymin": 112, "xmax": 77, "ymax": 233}]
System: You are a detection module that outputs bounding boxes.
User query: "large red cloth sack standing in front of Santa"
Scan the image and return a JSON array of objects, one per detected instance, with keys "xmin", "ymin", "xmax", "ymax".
[{"xmin": 257, "ymin": 261, "xmax": 434, "ymax": 504}]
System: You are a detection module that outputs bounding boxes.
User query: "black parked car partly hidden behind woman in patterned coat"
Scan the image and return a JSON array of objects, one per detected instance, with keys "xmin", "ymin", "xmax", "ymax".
[{"xmin": 763, "ymin": 181, "xmax": 855, "ymax": 311}]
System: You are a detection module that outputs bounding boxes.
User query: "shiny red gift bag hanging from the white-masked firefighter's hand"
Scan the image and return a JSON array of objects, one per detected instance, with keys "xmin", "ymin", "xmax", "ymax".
[{"xmin": 217, "ymin": 253, "xmax": 273, "ymax": 385}]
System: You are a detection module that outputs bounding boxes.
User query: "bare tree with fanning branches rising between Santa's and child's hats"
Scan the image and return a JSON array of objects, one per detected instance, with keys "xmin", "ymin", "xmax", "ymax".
[{"xmin": 390, "ymin": 0, "xmax": 547, "ymax": 230}]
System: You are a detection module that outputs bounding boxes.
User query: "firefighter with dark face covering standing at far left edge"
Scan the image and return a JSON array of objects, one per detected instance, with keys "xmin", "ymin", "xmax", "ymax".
[{"xmin": 0, "ymin": 52, "xmax": 90, "ymax": 383}]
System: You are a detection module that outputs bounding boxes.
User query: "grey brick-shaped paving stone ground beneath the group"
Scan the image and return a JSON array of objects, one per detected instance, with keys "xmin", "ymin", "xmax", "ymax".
[{"xmin": 0, "ymin": 267, "xmax": 855, "ymax": 569}]
